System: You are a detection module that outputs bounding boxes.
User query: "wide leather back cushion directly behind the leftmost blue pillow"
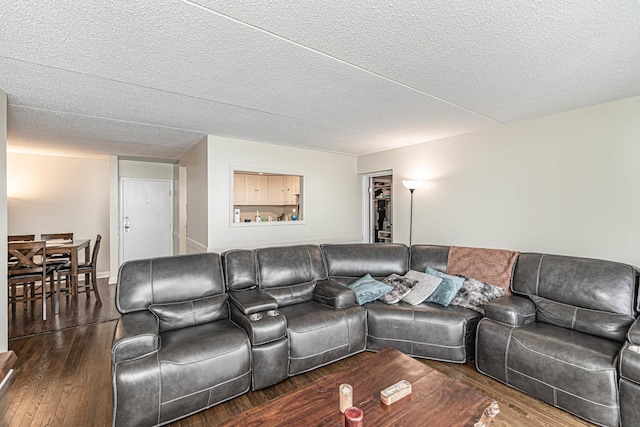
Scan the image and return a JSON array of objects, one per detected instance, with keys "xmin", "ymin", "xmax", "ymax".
[{"xmin": 322, "ymin": 243, "xmax": 408, "ymax": 278}]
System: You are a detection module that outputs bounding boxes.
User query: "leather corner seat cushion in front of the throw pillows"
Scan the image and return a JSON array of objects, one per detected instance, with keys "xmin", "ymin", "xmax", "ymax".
[{"xmin": 365, "ymin": 301, "xmax": 481, "ymax": 363}]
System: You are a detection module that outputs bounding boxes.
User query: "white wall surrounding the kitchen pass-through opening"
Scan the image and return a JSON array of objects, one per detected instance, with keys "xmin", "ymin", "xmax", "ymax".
[{"xmin": 208, "ymin": 136, "xmax": 363, "ymax": 252}]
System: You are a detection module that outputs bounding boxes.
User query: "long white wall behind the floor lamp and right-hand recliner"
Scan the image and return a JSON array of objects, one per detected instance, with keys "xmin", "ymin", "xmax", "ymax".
[{"xmin": 358, "ymin": 97, "xmax": 640, "ymax": 266}]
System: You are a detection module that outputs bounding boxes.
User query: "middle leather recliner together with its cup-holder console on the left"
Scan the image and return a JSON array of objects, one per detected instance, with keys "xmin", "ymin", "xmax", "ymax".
[{"xmin": 223, "ymin": 245, "xmax": 366, "ymax": 390}]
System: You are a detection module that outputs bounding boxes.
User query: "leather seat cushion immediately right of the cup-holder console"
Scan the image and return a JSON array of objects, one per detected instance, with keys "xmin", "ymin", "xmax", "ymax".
[{"xmin": 279, "ymin": 301, "xmax": 365, "ymax": 375}]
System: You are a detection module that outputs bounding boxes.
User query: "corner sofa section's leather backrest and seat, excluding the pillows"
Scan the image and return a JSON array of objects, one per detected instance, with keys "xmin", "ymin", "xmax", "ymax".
[{"xmin": 322, "ymin": 243, "xmax": 481, "ymax": 363}]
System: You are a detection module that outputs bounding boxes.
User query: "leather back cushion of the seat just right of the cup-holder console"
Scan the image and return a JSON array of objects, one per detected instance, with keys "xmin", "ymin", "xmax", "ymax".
[{"xmin": 256, "ymin": 245, "xmax": 327, "ymax": 290}]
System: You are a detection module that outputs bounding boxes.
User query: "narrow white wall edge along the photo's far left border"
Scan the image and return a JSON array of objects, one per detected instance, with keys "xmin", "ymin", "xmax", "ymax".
[{"xmin": 0, "ymin": 90, "xmax": 9, "ymax": 353}]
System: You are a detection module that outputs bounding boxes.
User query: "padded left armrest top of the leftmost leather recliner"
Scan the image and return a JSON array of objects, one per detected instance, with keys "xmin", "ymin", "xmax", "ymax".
[{"xmin": 111, "ymin": 311, "xmax": 160, "ymax": 364}]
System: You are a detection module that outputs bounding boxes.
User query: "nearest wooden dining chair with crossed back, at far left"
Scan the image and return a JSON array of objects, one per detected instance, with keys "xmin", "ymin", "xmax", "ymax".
[{"xmin": 7, "ymin": 241, "xmax": 55, "ymax": 320}]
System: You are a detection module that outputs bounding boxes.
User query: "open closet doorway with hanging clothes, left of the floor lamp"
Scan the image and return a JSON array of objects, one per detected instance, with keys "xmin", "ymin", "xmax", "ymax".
[{"xmin": 367, "ymin": 172, "xmax": 393, "ymax": 243}]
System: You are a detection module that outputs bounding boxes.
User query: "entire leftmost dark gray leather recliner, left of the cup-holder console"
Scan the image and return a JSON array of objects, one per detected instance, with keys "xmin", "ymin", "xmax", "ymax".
[{"xmin": 111, "ymin": 253, "xmax": 251, "ymax": 426}]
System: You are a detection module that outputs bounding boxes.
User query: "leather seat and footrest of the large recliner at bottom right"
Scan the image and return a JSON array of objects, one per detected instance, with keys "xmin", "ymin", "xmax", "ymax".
[{"xmin": 506, "ymin": 323, "xmax": 621, "ymax": 425}]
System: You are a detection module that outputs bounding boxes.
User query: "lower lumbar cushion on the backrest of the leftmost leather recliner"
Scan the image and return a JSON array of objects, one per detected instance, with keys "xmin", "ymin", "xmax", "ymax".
[{"xmin": 149, "ymin": 294, "xmax": 229, "ymax": 332}]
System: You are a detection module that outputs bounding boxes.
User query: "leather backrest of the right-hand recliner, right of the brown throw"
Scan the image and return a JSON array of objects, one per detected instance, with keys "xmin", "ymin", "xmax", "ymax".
[{"xmin": 512, "ymin": 253, "xmax": 637, "ymax": 341}]
